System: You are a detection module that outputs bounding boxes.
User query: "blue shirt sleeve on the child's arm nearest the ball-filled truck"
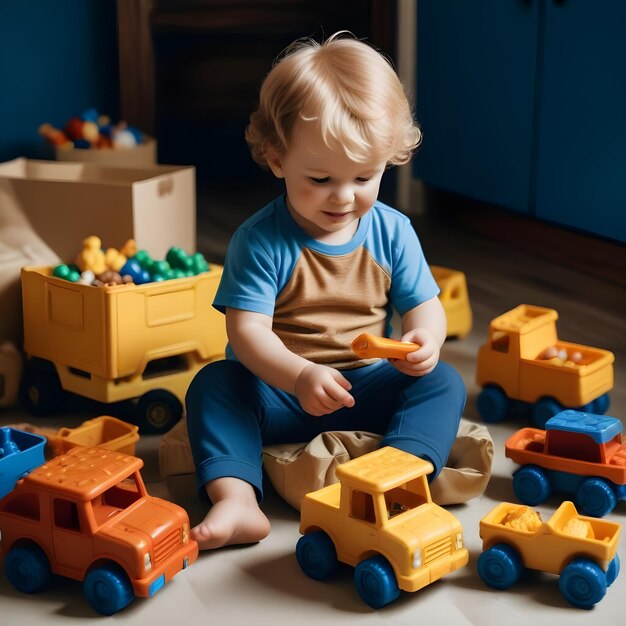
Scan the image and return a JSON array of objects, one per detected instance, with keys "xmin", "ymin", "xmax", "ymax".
[{"xmin": 213, "ymin": 227, "xmax": 277, "ymax": 316}]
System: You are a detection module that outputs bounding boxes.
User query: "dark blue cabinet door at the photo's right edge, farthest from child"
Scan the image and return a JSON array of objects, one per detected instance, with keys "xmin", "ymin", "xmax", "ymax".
[{"xmin": 536, "ymin": 0, "xmax": 626, "ymax": 241}]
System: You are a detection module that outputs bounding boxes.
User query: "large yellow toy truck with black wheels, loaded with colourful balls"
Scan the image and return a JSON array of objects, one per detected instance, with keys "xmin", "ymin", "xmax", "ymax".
[{"xmin": 21, "ymin": 265, "xmax": 226, "ymax": 432}]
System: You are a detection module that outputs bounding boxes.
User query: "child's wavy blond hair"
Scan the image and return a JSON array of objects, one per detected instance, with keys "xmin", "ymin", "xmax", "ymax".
[{"xmin": 245, "ymin": 31, "xmax": 422, "ymax": 166}]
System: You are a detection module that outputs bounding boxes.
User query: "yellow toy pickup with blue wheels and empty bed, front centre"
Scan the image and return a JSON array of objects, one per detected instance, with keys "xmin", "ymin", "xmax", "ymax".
[{"xmin": 296, "ymin": 447, "xmax": 469, "ymax": 608}]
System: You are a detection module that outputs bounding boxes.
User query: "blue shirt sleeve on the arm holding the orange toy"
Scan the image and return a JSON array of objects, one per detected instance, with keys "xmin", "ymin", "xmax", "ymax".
[{"xmin": 389, "ymin": 220, "xmax": 439, "ymax": 316}]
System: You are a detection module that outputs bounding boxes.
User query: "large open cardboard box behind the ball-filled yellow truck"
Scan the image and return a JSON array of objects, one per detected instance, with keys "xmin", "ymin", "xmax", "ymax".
[{"xmin": 0, "ymin": 158, "xmax": 196, "ymax": 262}]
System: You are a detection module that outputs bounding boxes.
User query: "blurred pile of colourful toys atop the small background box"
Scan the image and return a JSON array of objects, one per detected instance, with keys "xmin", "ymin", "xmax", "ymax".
[{"xmin": 39, "ymin": 109, "xmax": 144, "ymax": 150}]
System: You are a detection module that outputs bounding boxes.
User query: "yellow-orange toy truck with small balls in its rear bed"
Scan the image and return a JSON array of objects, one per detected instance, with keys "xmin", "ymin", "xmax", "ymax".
[{"xmin": 476, "ymin": 304, "xmax": 614, "ymax": 428}]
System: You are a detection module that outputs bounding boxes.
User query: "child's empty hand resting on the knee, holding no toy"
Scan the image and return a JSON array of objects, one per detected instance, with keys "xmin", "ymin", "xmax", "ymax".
[{"xmin": 295, "ymin": 363, "xmax": 354, "ymax": 417}]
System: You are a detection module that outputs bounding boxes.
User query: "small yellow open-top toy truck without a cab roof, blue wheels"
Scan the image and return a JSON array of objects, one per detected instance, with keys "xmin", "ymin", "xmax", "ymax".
[{"xmin": 477, "ymin": 501, "xmax": 622, "ymax": 609}]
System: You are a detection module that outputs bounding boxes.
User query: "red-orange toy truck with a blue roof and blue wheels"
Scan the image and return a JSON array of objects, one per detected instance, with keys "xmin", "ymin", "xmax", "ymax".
[{"xmin": 505, "ymin": 410, "xmax": 626, "ymax": 517}]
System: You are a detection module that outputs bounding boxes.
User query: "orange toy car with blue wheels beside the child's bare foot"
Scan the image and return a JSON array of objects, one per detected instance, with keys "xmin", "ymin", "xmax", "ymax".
[{"xmin": 0, "ymin": 446, "xmax": 198, "ymax": 615}]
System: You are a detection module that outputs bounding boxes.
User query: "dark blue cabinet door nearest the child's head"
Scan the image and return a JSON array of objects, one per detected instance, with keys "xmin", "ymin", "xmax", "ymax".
[{"xmin": 414, "ymin": 0, "xmax": 539, "ymax": 213}]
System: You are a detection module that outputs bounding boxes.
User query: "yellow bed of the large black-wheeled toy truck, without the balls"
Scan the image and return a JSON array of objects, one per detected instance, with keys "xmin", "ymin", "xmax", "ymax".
[{"xmin": 22, "ymin": 265, "xmax": 226, "ymax": 380}]
